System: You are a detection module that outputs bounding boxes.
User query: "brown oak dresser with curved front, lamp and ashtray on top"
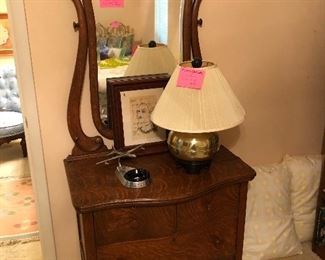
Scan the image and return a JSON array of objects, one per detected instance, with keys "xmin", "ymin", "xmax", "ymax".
[{"xmin": 65, "ymin": 146, "xmax": 255, "ymax": 260}]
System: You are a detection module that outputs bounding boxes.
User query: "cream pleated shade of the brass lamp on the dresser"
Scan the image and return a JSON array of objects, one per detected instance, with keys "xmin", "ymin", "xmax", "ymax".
[{"xmin": 151, "ymin": 62, "xmax": 245, "ymax": 133}]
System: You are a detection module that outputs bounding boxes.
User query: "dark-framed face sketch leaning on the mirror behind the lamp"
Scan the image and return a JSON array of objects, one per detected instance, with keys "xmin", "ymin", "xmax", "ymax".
[{"xmin": 107, "ymin": 74, "xmax": 169, "ymax": 154}]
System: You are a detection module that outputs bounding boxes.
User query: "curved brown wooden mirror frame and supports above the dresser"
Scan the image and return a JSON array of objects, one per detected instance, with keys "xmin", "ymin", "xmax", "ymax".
[{"xmin": 67, "ymin": 0, "xmax": 202, "ymax": 155}]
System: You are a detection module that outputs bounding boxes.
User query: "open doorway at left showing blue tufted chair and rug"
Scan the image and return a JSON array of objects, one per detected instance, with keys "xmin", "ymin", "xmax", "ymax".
[{"xmin": 0, "ymin": 0, "xmax": 42, "ymax": 260}]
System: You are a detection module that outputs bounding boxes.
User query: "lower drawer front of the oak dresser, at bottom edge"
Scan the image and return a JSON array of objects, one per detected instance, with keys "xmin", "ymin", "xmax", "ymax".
[{"xmin": 98, "ymin": 229, "xmax": 235, "ymax": 260}]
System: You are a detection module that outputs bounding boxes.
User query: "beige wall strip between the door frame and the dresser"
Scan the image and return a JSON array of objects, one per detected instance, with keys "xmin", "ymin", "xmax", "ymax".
[{"xmin": 25, "ymin": 0, "xmax": 85, "ymax": 260}]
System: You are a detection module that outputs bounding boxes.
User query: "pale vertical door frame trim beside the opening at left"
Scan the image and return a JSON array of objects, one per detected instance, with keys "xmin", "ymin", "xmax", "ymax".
[{"xmin": 1, "ymin": 0, "xmax": 56, "ymax": 260}]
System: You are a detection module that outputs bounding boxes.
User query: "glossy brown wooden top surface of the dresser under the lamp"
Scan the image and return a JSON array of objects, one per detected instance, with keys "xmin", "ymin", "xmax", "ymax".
[{"xmin": 64, "ymin": 146, "xmax": 255, "ymax": 212}]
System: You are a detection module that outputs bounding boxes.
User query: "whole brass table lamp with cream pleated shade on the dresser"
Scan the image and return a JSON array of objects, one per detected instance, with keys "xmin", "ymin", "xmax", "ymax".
[{"xmin": 151, "ymin": 61, "xmax": 245, "ymax": 173}]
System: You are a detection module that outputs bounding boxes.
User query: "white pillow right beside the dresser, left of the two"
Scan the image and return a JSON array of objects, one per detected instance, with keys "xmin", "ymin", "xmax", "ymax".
[{"xmin": 243, "ymin": 163, "xmax": 302, "ymax": 260}]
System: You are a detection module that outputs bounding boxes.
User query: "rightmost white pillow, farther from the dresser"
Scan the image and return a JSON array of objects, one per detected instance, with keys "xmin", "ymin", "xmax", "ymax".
[{"xmin": 284, "ymin": 155, "xmax": 322, "ymax": 242}]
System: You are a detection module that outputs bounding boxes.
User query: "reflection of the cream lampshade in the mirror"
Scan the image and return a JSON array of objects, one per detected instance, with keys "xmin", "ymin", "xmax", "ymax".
[{"xmin": 124, "ymin": 43, "xmax": 176, "ymax": 76}]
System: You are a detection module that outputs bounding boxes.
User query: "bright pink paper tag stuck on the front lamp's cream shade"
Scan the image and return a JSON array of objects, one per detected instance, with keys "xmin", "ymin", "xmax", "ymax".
[{"xmin": 177, "ymin": 68, "xmax": 205, "ymax": 89}]
